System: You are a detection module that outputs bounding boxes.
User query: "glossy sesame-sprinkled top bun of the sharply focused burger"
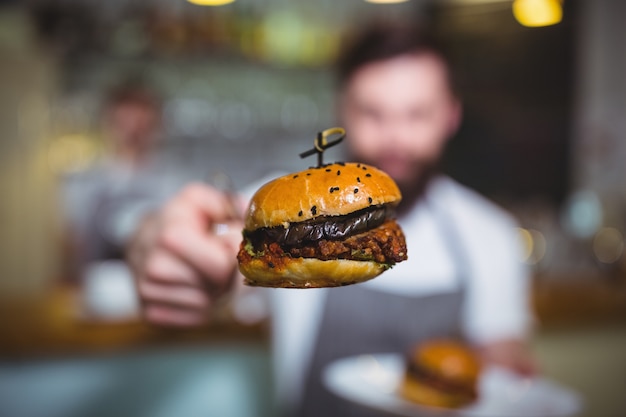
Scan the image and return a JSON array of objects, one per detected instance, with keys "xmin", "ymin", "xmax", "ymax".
[{"xmin": 245, "ymin": 162, "xmax": 402, "ymax": 231}]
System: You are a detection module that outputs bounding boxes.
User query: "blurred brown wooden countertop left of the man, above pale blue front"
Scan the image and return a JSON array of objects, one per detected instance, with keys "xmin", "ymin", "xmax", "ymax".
[{"xmin": 0, "ymin": 285, "xmax": 268, "ymax": 358}]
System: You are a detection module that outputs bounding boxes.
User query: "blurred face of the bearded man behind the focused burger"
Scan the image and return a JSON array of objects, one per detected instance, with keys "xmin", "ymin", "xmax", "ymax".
[{"xmin": 340, "ymin": 54, "xmax": 460, "ymax": 189}]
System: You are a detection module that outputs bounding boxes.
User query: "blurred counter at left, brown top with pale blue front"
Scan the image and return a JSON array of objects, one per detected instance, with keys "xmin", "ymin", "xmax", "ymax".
[{"xmin": 0, "ymin": 286, "xmax": 275, "ymax": 417}]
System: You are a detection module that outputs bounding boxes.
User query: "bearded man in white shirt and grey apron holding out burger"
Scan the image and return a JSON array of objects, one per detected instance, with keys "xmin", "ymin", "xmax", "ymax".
[{"xmin": 129, "ymin": 26, "xmax": 534, "ymax": 416}]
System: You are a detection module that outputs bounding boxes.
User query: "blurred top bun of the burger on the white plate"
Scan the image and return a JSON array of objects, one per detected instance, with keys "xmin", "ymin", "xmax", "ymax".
[{"xmin": 411, "ymin": 340, "xmax": 480, "ymax": 384}]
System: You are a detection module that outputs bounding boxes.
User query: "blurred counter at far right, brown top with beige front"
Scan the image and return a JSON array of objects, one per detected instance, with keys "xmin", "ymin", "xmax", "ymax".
[{"xmin": 531, "ymin": 271, "xmax": 626, "ymax": 417}]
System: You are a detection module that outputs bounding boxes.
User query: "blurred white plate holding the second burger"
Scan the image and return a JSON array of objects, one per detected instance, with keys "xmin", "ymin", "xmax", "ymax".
[{"xmin": 323, "ymin": 354, "xmax": 581, "ymax": 417}]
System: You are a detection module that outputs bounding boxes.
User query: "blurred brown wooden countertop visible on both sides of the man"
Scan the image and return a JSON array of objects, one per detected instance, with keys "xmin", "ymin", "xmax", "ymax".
[{"xmin": 0, "ymin": 275, "xmax": 626, "ymax": 357}]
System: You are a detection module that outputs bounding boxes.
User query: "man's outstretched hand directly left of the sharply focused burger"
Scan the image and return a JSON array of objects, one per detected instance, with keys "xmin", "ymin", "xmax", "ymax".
[{"xmin": 127, "ymin": 184, "xmax": 243, "ymax": 326}]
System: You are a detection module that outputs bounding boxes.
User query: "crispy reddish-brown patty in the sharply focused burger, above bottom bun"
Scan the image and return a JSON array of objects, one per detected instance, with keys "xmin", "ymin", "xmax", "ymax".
[{"xmin": 238, "ymin": 219, "xmax": 407, "ymax": 267}]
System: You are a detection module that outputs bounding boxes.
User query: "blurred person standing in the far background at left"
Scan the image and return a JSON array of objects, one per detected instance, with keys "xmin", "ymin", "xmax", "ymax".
[{"xmin": 63, "ymin": 81, "xmax": 181, "ymax": 265}]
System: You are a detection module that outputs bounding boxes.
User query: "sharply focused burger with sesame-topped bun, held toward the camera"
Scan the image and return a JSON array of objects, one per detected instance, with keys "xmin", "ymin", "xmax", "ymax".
[{"xmin": 237, "ymin": 162, "xmax": 407, "ymax": 288}]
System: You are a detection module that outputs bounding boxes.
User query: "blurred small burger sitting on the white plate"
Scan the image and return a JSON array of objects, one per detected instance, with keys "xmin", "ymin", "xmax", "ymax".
[{"xmin": 400, "ymin": 340, "xmax": 480, "ymax": 408}]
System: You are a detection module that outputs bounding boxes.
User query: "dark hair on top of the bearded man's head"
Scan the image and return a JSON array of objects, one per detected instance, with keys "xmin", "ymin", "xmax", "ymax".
[{"xmin": 336, "ymin": 23, "xmax": 456, "ymax": 92}]
